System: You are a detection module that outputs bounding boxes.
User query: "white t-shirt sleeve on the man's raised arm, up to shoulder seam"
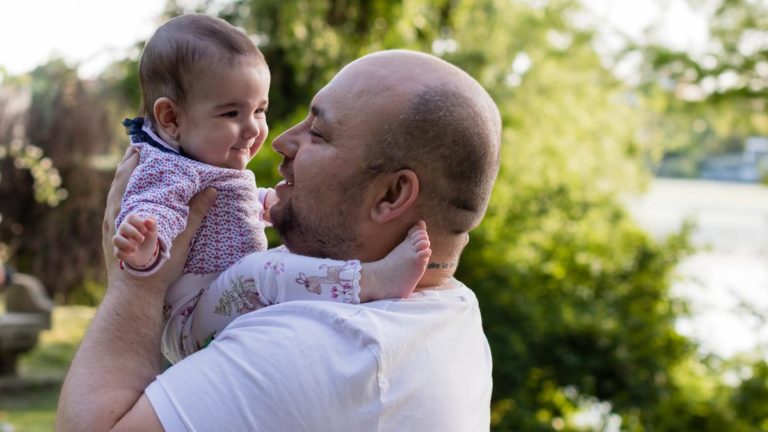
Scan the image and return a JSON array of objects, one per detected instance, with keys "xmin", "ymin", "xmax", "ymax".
[{"xmin": 146, "ymin": 302, "xmax": 381, "ymax": 432}]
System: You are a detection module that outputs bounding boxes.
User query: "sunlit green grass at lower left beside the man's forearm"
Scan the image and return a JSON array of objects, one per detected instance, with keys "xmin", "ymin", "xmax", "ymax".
[{"xmin": 0, "ymin": 306, "xmax": 95, "ymax": 432}]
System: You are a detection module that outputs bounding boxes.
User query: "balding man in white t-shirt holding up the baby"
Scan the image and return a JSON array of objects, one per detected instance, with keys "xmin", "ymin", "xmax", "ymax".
[{"xmin": 57, "ymin": 51, "xmax": 501, "ymax": 432}]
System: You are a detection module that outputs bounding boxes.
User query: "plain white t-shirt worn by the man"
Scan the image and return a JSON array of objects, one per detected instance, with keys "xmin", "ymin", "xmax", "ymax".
[{"xmin": 146, "ymin": 281, "xmax": 492, "ymax": 432}]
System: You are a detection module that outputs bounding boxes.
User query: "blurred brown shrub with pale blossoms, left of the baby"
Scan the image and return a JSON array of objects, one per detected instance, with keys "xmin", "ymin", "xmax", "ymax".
[{"xmin": 0, "ymin": 59, "xmax": 117, "ymax": 303}]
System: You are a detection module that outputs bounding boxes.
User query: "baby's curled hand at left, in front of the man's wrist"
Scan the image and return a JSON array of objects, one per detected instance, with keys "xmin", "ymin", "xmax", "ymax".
[{"xmin": 112, "ymin": 213, "xmax": 160, "ymax": 269}]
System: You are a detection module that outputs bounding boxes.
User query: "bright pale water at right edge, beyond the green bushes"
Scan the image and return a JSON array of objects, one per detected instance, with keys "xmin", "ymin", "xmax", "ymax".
[{"xmin": 628, "ymin": 179, "xmax": 768, "ymax": 357}]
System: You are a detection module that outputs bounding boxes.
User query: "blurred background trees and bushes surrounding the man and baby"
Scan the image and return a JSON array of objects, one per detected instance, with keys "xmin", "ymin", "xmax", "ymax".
[{"xmin": 0, "ymin": 0, "xmax": 768, "ymax": 432}]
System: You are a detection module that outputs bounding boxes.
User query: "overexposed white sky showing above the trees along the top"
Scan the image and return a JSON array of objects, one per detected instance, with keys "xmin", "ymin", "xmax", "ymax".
[{"xmin": 0, "ymin": 0, "xmax": 707, "ymax": 78}]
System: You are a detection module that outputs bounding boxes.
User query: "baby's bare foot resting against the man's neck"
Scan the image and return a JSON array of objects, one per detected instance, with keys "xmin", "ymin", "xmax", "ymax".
[{"xmin": 360, "ymin": 221, "xmax": 432, "ymax": 302}]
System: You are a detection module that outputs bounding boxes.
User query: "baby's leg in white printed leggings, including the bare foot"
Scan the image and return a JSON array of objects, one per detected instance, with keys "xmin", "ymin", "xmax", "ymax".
[{"xmin": 163, "ymin": 222, "xmax": 431, "ymax": 361}]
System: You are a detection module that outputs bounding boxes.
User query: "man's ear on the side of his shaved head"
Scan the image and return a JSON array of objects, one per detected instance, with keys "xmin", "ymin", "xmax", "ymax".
[{"xmin": 371, "ymin": 169, "xmax": 419, "ymax": 223}]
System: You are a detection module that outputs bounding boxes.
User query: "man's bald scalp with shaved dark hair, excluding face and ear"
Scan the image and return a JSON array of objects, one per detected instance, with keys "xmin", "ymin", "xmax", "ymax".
[{"xmin": 344, "ymin": 50, "xmax": 501, "ymax": 235}]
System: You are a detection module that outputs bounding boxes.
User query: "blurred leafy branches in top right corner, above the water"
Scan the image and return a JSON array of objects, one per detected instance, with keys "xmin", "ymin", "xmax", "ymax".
[{"xmin": 617, "ymin": 0, "xmax": 768, "ymax": 173}]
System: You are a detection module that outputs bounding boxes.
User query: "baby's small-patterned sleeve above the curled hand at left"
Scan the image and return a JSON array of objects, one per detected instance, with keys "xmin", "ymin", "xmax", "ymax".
[{"xmin": 115, "ymin": 151, "xmax": 202, "ymax": 270}]
